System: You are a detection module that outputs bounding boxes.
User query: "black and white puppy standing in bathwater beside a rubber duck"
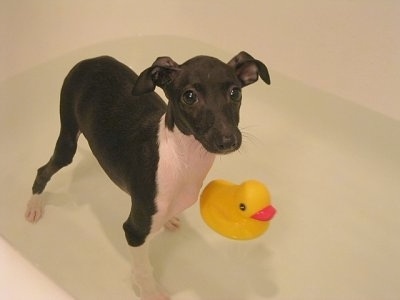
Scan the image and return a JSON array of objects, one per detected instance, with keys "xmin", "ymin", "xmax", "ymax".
[{"xmin": 25, "ymin": 51, "xmax": 270, "ymax": 300}]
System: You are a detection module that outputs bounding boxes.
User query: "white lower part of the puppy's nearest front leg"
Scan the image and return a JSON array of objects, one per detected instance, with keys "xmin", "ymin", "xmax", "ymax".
[{"xmin": 130, "ymin": 237, "xmax": 169, "ymax": 300}]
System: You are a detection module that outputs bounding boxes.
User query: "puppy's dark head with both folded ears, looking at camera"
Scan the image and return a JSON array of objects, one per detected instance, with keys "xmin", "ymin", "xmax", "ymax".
[{"xmin": 132, "ymin": 52, "xmax": 270, "ymax": 154}]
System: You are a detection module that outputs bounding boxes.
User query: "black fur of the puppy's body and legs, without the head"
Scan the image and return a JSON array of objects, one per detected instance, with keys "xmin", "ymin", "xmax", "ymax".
[{"xmin": 32, "ymin": 56, "xmax": 167, "ymax": 246}]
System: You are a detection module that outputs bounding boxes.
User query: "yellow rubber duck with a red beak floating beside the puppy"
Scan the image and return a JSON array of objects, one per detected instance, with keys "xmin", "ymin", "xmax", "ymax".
[{"xmin": 200, "ymin": 179, "xmax": 276, "ymax": 240}]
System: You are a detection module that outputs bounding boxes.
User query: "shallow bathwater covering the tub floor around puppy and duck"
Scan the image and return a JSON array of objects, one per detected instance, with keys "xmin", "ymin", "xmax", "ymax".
[{"xmin": 0, "ymin": 37, "xmax": 400, "ymax": 300}]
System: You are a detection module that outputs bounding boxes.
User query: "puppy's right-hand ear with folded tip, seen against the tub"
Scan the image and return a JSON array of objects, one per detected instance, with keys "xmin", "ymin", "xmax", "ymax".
[{"xmin": 228, "ymin": 51, "xmax": 271, "ymax": 86}]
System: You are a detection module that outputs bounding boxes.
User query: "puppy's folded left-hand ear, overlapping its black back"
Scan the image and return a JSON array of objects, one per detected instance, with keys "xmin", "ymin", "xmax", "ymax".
[{"xmin": 132, "ymin": 56, "xmax": 180, "ymax": 96}]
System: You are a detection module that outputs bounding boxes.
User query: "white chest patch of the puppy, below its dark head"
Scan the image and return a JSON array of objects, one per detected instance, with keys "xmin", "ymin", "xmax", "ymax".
[{"xmin": 153, "ymin": 116, "xmax": 215, "ymax": 228}]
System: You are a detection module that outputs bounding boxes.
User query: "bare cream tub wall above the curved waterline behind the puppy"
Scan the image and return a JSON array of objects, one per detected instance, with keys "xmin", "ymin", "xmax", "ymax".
[{"xmin": 0, "ymin": 0, "xmax": 400, "ymax": 119}]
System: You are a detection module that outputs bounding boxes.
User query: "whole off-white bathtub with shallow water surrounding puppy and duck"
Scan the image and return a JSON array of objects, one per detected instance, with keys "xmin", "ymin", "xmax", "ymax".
[{"xmin": 0, "ymin": 0, "xmax": 400, "ymax": 300}]
